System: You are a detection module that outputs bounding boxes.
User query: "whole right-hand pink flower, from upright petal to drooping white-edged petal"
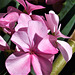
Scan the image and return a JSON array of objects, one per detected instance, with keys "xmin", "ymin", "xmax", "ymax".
[{"xmin": 45, "ymin": 11, "xmax": 72, "ymax": 61}]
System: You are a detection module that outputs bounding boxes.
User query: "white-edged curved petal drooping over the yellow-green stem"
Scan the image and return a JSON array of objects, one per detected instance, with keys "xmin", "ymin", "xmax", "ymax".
[{"xmin": 57, "ymin": 40, "xmax": 72, "ymax": 62}]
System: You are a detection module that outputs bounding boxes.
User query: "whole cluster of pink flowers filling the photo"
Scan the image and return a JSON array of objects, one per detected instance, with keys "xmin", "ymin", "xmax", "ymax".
[{"xmin": 0, "ymin": 0, "xmax": 72, "ymax": 75}]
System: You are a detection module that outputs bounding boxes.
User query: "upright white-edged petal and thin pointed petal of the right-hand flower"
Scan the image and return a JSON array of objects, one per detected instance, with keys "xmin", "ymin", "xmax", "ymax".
[{"xmin": 45, "ymin": 11, "xmax": 70, "ymax": 38}]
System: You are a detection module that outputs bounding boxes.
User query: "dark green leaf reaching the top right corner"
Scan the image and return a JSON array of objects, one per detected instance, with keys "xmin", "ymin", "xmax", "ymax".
[{"xmin": 58, "ymin": 0, "xmax": 75, "ymax": 21}]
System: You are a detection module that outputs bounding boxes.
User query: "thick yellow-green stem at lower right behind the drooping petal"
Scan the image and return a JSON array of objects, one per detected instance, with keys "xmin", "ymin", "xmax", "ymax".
[{"xmin": 50, "ymin": 40, "xmax": 75, "ymax": 75}]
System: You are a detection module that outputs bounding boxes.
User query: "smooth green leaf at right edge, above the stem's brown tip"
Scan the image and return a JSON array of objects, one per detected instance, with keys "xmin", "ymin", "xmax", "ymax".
[{"xmin": 61, "ymin": 15, "xmax": 75, "ymax": 35}]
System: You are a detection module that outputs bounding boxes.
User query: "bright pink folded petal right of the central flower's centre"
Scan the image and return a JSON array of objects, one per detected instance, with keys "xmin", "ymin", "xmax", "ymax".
[{"xmin": 38, "ymin": 36, "xmax": 58, "ymax": 54}]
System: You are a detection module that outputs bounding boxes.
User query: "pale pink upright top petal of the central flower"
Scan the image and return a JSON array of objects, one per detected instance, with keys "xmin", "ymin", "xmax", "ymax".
[{"xmin": 28, "ymin": 21, "xmax": 47, "ymax": 42}]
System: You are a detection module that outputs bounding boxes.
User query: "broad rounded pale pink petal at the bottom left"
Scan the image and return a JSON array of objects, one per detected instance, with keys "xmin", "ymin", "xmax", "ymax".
[{"xmin": 5, "ymin": 52, "xmax": 30, "ymax": 75}]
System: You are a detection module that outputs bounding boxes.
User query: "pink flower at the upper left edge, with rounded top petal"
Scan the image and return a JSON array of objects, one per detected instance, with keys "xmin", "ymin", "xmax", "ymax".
[{"xmin": 0, "ymin": 12, "xmax": 19, "ymax": 34}]
